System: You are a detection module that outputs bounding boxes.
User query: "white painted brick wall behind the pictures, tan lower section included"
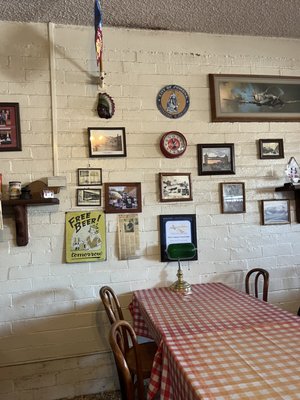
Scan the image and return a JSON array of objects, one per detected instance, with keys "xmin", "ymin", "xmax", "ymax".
[{"xmin": 0, "ymin": 22, "xmax": 300, "ymax": 400}]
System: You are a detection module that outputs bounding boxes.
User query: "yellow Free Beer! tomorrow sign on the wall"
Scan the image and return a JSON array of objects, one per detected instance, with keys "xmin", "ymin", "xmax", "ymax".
[{"xmin": 65, "ymin": 211, "xmax": 106, "ymax": 263}]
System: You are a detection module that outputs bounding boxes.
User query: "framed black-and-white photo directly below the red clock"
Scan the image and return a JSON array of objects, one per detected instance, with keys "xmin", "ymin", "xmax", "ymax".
[{"xmin": 159, "ymin": 172, "xmax": 193, "ymax": 202}]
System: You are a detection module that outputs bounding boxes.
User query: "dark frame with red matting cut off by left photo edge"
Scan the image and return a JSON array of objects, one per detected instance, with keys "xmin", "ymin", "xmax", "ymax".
[{"xmin": 0, "ymin": 103, "xmax": 22, "ymax": 151}]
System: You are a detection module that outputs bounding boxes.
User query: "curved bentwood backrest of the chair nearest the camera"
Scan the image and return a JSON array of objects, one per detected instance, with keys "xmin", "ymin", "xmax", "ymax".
[{"xmin": 109, "ymin": 320, "xmax": 145, "ymax": 400}]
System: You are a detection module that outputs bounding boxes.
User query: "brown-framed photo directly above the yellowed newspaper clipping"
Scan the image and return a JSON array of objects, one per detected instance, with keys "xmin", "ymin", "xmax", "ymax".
[{"xmin": 104, "ymin": 182, "xmax": 142, "ymax": 213}]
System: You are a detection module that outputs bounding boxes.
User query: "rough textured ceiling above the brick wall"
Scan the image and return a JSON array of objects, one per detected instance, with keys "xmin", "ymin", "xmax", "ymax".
[{"xmin": 0, "ymin": 0, "xmax": 300, "ymax": 38}]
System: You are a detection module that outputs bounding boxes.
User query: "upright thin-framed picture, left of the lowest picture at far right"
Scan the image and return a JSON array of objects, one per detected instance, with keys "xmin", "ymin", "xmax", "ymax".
[{"xmin": 220, "ymin": 182, "xmax": 246, "ymax": 214}]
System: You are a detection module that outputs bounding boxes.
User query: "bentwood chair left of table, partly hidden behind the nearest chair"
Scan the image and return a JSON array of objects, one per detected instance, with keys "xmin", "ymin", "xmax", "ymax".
[{"xmin": 99, "ymin": 286, "xmax": 157, "ymax": 400}]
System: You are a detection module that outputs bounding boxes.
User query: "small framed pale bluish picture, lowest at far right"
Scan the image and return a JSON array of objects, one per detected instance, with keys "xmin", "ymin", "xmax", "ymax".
[{"xmin": 262, "ymin": 200, "xmax": 291, "ymax": 225}]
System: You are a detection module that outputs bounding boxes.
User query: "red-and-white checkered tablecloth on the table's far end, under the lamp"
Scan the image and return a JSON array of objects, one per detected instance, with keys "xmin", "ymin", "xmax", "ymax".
[{"xmin": 129, "ymin": 283, "xmax": 299, "ymax": 400}]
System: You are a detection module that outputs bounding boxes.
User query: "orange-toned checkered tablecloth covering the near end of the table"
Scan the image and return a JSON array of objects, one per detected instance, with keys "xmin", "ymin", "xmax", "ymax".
[{"xmin": 163, "ymin": 319, "xmax": 300, "ymax": 400}]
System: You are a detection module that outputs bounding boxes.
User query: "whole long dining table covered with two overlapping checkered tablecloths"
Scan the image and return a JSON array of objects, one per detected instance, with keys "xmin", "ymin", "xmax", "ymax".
[{"xmin": 129, "ymin": 282, "xmax": 300, "ymax": 400}]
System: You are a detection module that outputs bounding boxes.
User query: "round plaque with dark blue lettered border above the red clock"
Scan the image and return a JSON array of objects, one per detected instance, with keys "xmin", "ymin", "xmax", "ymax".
[{"xmin": 156, "ymin": 85, "xmax": 190, "ymax": 118}]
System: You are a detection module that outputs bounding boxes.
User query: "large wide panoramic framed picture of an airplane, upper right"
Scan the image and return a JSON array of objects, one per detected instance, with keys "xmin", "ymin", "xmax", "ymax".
[{"xmin": 209, "ymin": 74, "xmax": 300, "ymax": 122}]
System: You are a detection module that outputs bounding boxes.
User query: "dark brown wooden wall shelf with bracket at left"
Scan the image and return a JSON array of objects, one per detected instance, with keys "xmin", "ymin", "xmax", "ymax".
[{"xmin": 2, "ymin": 198, "xmax": 59, "ymax": 246}]
